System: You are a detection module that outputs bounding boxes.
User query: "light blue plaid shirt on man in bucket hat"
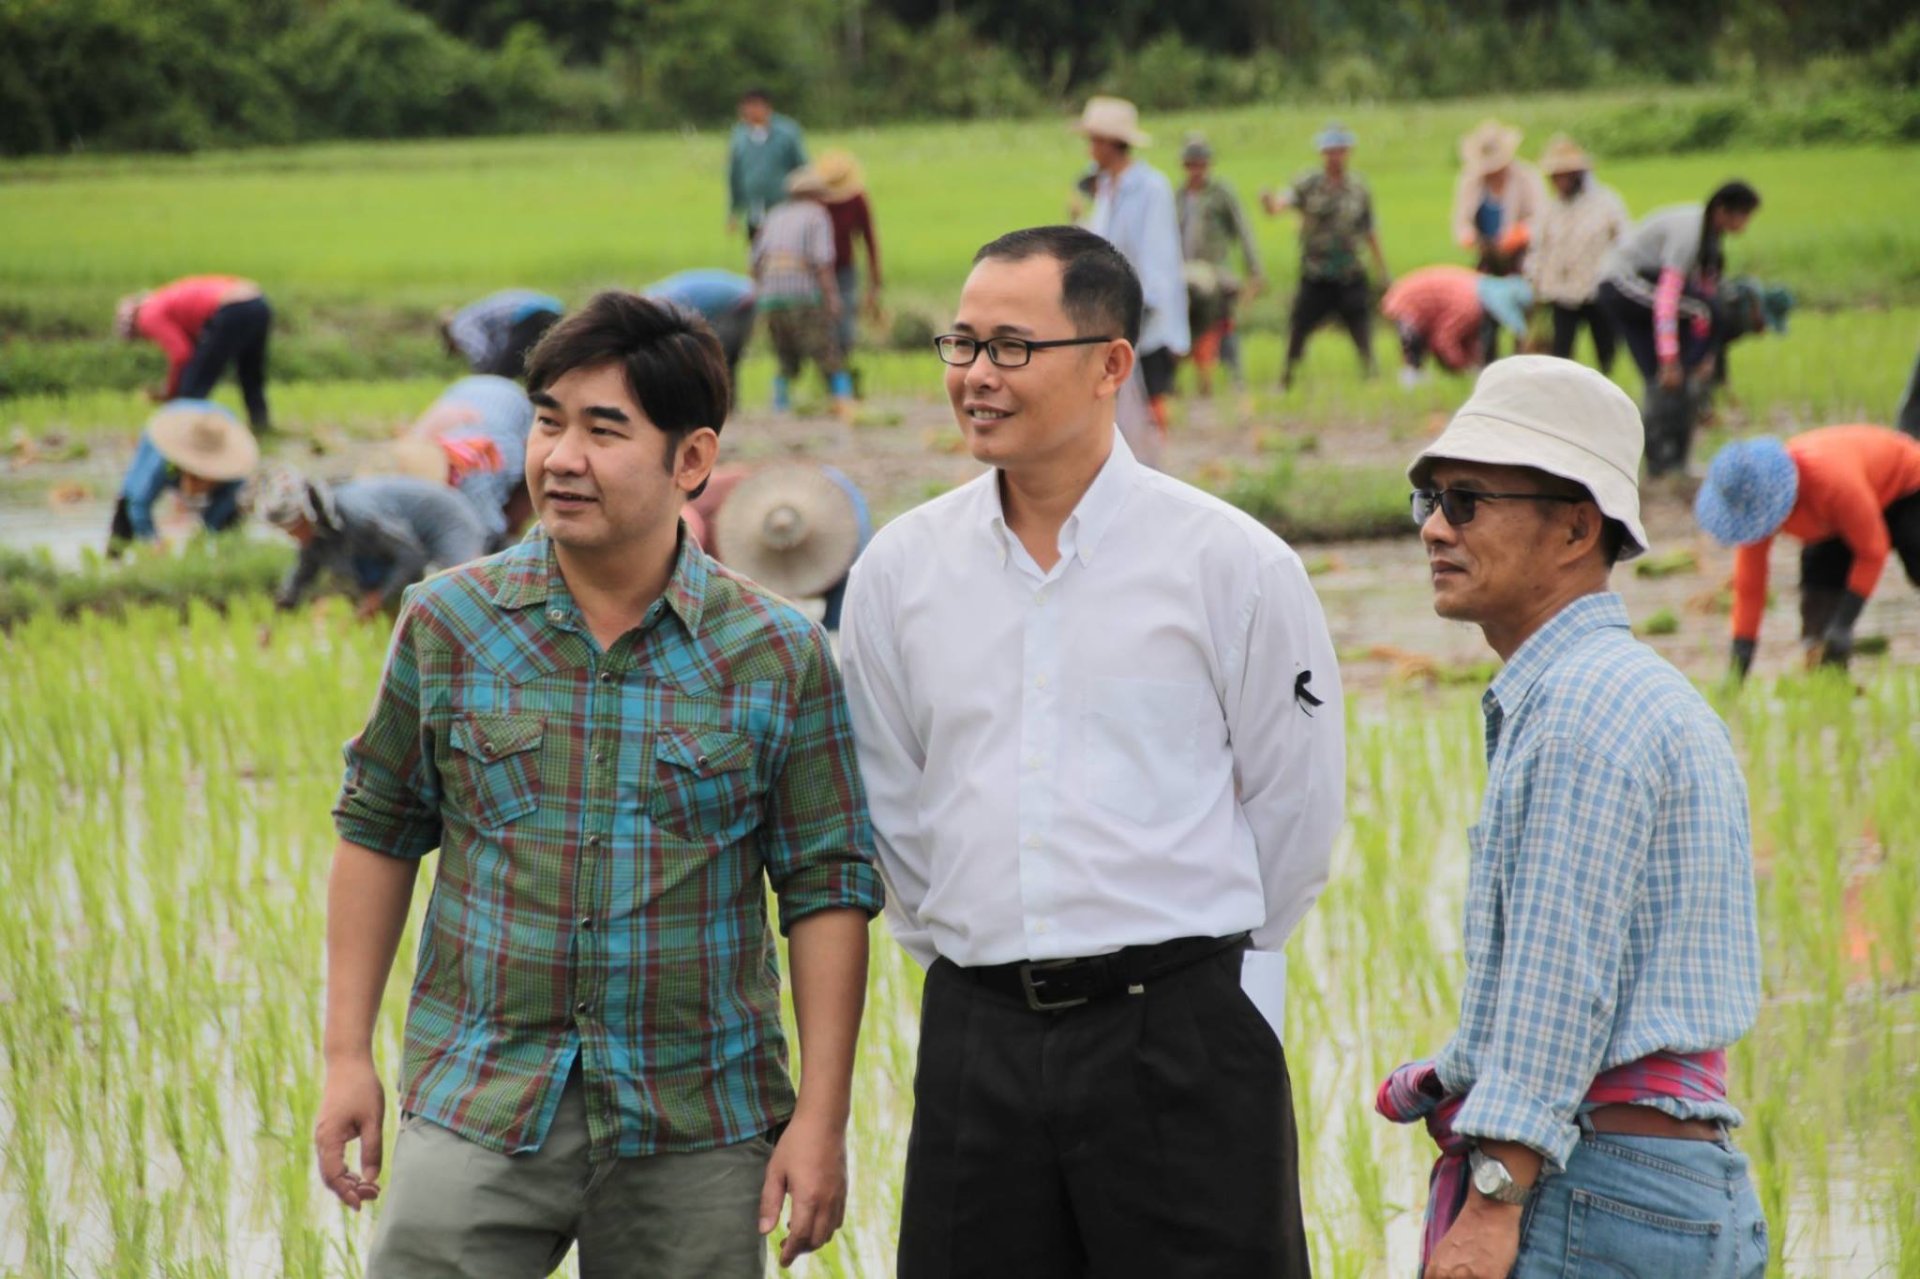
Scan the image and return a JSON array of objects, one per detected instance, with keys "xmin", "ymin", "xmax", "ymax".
[{"xmin": 1436, "ymin": 593, "xmax": 1761, "ymax": 1168}]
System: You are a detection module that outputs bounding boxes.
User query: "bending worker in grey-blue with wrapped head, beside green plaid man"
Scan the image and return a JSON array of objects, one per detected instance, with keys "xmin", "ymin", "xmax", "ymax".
[{"xmin": 259, "ymin": 471, "xmax": 486, "ymax": 620}]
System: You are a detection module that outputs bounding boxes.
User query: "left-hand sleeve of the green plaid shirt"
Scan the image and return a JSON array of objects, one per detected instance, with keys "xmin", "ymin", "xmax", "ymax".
[{"xmin": 334, "ymin": 597, "xmax": 440, "ymax": 858}]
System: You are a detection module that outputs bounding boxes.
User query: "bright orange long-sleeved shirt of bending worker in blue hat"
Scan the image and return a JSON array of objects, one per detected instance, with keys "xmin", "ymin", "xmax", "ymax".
[{"xmin": 1734, "ymin": 426, "xmax": 1920, "ymax": 640}]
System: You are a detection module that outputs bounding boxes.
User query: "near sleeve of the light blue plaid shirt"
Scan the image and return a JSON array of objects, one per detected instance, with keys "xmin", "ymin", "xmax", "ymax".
[{"xmin": 1453, "ymin": 737, "xmax": 1655, "ymax": 1168}]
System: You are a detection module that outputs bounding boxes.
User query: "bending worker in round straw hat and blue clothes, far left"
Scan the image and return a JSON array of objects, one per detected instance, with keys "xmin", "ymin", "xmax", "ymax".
[{"xmin": 108, "ymin": 399, "xmax": 259, "ymax": 555}]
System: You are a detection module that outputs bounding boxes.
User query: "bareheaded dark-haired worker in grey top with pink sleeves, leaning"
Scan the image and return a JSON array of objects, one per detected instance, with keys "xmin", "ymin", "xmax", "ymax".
[{"xmin": 1597, "ymin": 181, "xmax": 1761, "ymax": 476}]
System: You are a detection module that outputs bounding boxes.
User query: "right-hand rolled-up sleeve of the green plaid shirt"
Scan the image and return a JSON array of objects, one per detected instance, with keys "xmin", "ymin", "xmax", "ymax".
[{"xmin": 762, "ymin": 628, "xmax": 885, "ymax": 933}]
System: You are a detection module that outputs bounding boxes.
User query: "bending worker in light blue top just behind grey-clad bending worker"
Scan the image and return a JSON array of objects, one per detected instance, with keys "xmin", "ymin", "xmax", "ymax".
[{"xmin": 392, "ymin": 374, "xmax": 534, "ymax": 551}]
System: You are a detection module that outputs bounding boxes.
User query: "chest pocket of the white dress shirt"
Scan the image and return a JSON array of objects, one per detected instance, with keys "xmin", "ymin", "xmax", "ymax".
[{"xmin": 1081, "ymin": 678, "xmax": 1225, "ymax": 826}]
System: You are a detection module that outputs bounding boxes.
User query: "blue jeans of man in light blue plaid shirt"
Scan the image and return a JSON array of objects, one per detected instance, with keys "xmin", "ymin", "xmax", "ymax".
[{"xmin": 1513, "ymin": 1120, "xmax": 1766, "ymax": 1279}]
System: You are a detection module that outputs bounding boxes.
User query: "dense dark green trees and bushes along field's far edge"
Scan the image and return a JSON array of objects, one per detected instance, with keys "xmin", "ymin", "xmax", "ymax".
[{"xmin": 11, "ymin": 0, "xmax": 1920, "ymax": 154}]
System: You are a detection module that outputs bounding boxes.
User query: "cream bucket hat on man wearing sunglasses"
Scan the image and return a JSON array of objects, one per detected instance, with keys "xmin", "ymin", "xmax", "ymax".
[{"xmin": 1407, "ymin": 355, "xmax": 1647, "ymax": 559}]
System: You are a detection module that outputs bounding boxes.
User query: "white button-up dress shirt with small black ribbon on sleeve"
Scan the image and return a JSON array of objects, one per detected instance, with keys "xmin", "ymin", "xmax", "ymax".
[{"xmin": 841, "ymin": 432, "xmax": 1346, "ymax": 998}]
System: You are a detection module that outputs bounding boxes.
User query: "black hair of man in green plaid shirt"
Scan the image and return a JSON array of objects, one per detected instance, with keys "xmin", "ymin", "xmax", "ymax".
[{"xmin": 526, "ymin": 290, "xmax": 733, "ymax": 497}]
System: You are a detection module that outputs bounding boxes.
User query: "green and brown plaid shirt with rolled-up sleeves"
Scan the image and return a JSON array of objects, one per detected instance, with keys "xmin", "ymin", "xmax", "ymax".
[{"xmin": 334, "ymin": 538, "xmax": 881, "ymax": 1158}]
